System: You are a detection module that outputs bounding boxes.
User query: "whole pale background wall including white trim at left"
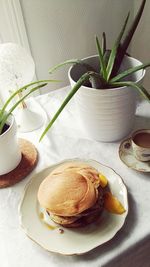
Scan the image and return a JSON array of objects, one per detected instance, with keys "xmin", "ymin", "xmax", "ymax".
[{"xmin": 0, "ymin": 0, "xmax": 150, "ymax": 94}]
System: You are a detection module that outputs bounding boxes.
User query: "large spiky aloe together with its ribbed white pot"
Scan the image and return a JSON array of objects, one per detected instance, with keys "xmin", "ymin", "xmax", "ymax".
[{"xmin": 40, "ymin": 0, "xmax": 150, "ymax": 141}]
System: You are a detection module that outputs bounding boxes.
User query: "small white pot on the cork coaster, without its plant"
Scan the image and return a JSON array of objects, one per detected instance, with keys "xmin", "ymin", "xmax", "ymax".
[{"xmin": 0, "ymin": 115, "xmax": 21, "ymax": 175}]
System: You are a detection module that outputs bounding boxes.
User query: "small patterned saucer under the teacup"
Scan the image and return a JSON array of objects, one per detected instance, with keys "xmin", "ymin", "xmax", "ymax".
[{"xmin": 119, "ymin": 138, "xmax": 150, "ymax": 172}]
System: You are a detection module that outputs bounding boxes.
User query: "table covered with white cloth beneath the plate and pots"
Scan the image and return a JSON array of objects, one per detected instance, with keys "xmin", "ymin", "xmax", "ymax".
[{"xmin": 0, "ymin": 87, "xmax": 150, "ymax": 267}]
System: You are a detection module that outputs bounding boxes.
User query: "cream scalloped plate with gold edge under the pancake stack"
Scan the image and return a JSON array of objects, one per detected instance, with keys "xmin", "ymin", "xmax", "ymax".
[{"xmin": 19, "ymin": 159, "xmax": 128, "ymax": 255}]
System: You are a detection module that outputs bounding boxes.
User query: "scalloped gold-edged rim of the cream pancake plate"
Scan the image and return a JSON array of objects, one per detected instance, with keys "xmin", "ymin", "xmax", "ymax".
[{"xmin": 18, "ymin": 158, "xmax": 129, "ymax": 256}]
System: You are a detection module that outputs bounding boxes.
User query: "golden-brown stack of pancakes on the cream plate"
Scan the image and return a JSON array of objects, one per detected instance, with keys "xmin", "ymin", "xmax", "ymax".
[{"xmin": 37, "ymin": 161, "xmax": 104, "ymax": 227}]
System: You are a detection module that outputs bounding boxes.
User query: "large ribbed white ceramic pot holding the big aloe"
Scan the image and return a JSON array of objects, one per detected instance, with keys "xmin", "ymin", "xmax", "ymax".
[{"xmin": 68, "ymin": 55, "xmax": 145, "ymax": 142}]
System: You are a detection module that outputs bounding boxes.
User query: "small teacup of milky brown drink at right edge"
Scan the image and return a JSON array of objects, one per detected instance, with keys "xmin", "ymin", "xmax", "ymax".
[{"xmin": 131, "ymin": 129, "xmax": 150, "ymax": 161}]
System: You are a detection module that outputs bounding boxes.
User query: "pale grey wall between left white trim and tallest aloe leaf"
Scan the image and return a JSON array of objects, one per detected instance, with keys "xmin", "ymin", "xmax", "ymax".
[{"xmin": 20, "ymin": 0, "xmax": 134, "ymax": 92}]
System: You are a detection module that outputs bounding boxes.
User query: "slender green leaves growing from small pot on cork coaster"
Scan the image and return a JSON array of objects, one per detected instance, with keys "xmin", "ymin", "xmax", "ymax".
[{"xmin": 0, "ymin": 80, "xmax": 58, "ymax": 134}]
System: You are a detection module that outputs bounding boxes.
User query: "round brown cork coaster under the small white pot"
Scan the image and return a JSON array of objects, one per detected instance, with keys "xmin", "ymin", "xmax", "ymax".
[{"xmin": 0, "ymin": 139, "xmax": 38, "ymax": 188}]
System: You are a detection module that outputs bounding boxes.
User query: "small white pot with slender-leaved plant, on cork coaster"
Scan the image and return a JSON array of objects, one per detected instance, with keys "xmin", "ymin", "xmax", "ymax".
[{"xmin": 0, "ymin": 80, "xmax": 54, "ymax": 175}]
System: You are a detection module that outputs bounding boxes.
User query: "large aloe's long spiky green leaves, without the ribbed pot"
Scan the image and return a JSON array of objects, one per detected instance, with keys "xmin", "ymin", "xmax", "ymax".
[{"xmin": 40, "ymin": 0, "xmax": 150, "ymax": 140}]
